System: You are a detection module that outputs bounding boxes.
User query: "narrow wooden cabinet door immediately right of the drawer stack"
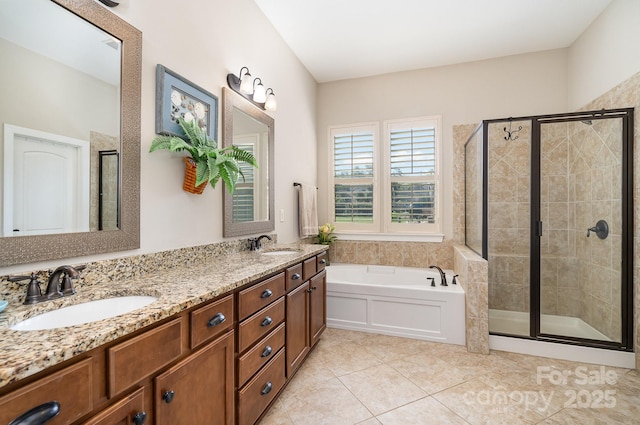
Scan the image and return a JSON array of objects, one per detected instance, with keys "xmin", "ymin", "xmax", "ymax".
[{"xmin": 285, "ymin": 284, "xmax": 309, "ymax": 377}]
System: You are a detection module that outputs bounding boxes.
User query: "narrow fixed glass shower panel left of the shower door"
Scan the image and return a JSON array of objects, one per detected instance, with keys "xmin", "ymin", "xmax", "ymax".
[{"xmin": 487, "ymin": 121, "xmax": 531, "ymax": 335}]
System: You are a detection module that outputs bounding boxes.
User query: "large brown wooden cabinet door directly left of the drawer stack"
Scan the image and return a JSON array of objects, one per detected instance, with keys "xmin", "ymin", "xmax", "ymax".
[{"xmin": 154, "ymin": 331, "xmax": 235, "ymax": 425}]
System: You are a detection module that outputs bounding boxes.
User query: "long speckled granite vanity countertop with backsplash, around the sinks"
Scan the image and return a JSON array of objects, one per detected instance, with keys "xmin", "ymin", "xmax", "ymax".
[{"xmin": 0, "ymin": 238, "xmax": 326, "ymax": 387}]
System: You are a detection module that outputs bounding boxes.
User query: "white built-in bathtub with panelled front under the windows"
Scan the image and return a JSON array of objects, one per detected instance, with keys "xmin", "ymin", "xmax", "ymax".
[{"xmin": 326, "ymin": 264, "xmax": 465, "ymax": 345}]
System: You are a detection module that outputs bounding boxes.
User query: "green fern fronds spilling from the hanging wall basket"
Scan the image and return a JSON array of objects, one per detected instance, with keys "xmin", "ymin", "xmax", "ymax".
[{"xmin": 149, "ymin": 118, "xmax": 258, "ymax": 194}]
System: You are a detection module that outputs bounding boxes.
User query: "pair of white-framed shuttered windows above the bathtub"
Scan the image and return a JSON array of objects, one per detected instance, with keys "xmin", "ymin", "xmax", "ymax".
[{"xmin": 329, "ymin": 117, "xmax": 441, "ymax": 234}]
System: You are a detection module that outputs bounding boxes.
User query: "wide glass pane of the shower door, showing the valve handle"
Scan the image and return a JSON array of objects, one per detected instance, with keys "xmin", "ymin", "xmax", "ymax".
[{"xmin": 540, "ymin": 118, "xmax": 623, "ymax": 342}]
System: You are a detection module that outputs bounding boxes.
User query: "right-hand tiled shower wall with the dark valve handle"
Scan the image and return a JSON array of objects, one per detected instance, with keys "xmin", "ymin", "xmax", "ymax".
[{"xmin": 568, "ymin": 120, "xmax": 622, "ymax": 341}]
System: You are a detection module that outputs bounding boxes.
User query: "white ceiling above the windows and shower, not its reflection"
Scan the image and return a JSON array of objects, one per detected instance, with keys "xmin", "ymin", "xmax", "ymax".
[{"xmin": 254, "ymin": 0, "xmax": 611, "ymax": 83}]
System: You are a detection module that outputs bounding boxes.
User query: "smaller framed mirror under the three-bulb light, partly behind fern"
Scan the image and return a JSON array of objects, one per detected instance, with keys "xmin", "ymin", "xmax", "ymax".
[{"xmin": 222, "ymin": 87, "xmax": 275, "ymax": 237}]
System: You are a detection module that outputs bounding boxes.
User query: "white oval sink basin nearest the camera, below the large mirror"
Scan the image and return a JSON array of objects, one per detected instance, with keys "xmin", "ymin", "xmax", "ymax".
[{"xmin": 9, "ymin": 295, "xmax": 157, "ymax": 331}]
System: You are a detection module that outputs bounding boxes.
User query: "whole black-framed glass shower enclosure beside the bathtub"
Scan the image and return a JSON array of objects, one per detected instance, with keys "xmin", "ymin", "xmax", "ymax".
[{"xmin": 465, "ymin": 108, "xmax": 633, "ymax": 351}]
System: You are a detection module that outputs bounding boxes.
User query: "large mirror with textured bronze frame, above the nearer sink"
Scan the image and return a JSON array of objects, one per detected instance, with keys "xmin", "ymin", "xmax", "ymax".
[{"xmin": 0, "ymin": 0, "xmax": 142, "ymax": 267}]
